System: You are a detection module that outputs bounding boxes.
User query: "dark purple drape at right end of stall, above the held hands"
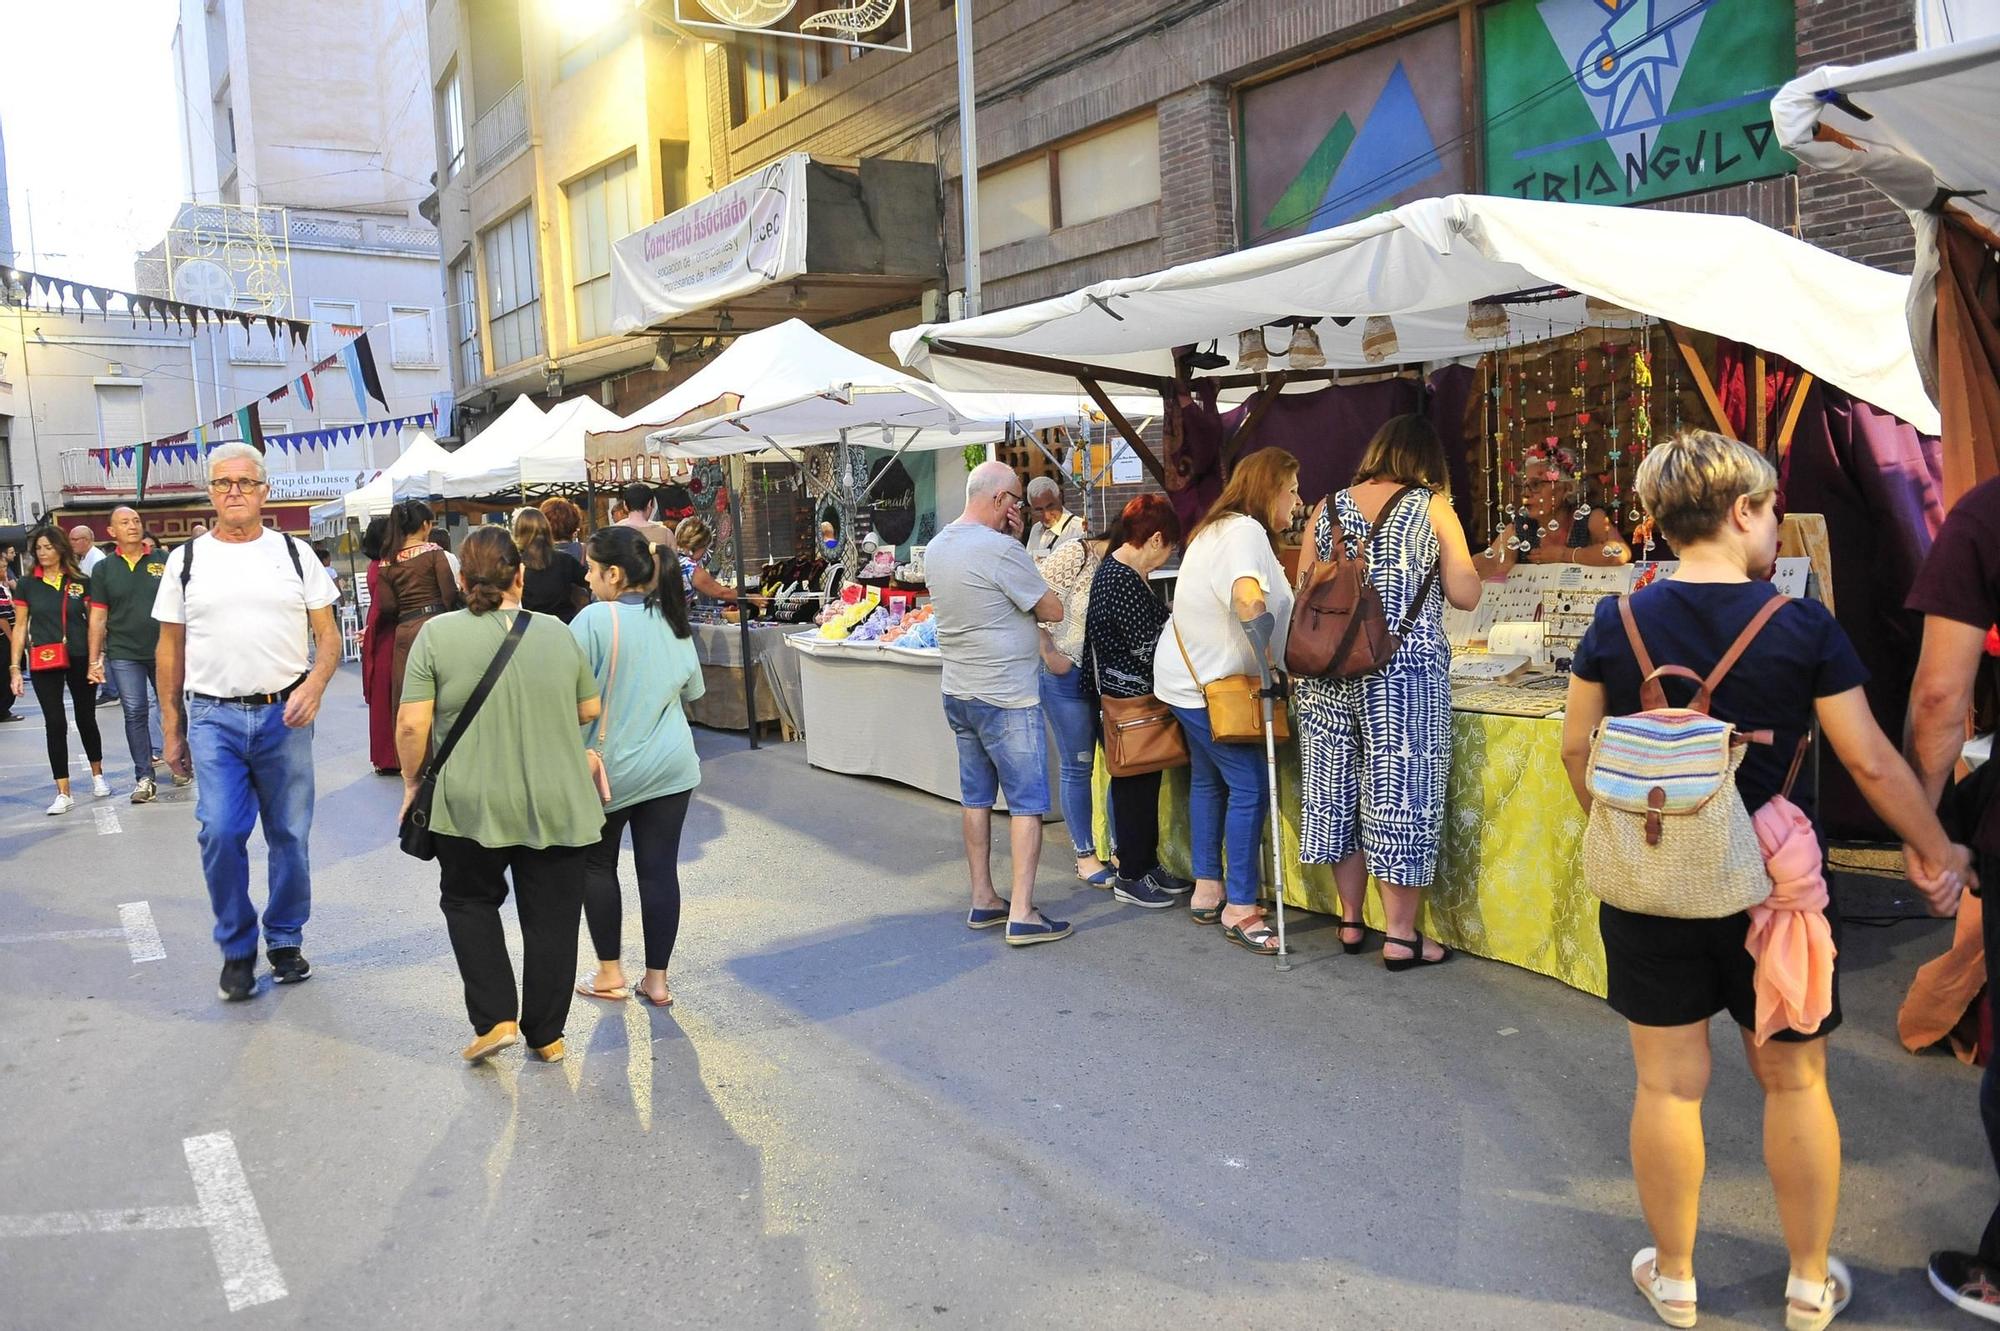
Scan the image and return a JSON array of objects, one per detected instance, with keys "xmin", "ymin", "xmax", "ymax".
[{"xmin": 1782, "ymin": 382, "xmax": 1944, "ymax": 839}]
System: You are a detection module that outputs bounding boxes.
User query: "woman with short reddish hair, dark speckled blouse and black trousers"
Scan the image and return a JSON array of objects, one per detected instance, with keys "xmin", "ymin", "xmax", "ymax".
[{"xmin": 1082, "ymin": 494, "xmax": 1192, "ymax": 905}]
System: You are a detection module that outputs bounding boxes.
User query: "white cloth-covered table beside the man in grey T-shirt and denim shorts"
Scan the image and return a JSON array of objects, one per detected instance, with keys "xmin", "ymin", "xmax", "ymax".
[{"xmin": 786, "ymin": 638, "xmax": 1062, "ymax": 821}]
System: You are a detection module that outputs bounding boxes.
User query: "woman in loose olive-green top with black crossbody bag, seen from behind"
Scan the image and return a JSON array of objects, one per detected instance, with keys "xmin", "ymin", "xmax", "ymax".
[{"xmin": 396, "ymin": 528, "xmax": 610, "ymax": 1063}]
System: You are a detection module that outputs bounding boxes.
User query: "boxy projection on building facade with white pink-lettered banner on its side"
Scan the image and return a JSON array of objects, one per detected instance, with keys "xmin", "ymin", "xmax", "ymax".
[{"xmin": 612, "ymin": 152, "xmax": 944, "ymax": 334}]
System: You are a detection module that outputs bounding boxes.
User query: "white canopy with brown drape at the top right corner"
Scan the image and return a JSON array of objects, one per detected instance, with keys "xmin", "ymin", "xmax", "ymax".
[{"xmin": 1770, "ymin": 36, "xmax": 2000, "ymax": 502}]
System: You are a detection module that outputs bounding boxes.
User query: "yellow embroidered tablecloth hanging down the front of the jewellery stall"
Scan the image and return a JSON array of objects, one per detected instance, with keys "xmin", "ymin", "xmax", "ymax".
[{"xmin": 1096, "ymin": 711, "xmax": 1604, "ymax": 997}]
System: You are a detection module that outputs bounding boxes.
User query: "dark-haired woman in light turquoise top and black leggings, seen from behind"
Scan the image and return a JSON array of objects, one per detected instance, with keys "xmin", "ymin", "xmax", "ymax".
[{"xmin": 570, "ymin": 528, "xmax": 702, "ymax": 1007}]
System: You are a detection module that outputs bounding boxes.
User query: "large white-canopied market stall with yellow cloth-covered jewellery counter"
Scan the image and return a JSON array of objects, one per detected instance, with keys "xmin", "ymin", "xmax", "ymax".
[{"xmin": 894, "ymin": 196, "xmax": 1938, "ymax": 993}]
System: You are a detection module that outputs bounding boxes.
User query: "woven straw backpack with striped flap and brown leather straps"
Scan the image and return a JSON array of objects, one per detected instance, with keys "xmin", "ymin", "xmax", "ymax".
[{"xmin": 1584, "ymin": 596, "xmax": 1796, "ymax": 919}]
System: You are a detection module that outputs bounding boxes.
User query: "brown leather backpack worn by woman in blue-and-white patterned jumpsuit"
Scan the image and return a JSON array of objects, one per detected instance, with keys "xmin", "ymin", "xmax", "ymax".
[{"xmin": 1284, "ymin": 486, "xmax": 1442, "ymax": 679}]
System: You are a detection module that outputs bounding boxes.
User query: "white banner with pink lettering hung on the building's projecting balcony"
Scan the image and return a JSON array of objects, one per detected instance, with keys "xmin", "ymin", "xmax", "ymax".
[{"xmin": 612, "ymin": 152, "xmax": 806, "ymax": 334}]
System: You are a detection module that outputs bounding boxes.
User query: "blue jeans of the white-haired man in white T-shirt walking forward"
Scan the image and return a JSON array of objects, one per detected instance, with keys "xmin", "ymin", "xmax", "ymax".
[{"xmin": 188, "ymin": 697, "xmax": 312, "ymax": 961}]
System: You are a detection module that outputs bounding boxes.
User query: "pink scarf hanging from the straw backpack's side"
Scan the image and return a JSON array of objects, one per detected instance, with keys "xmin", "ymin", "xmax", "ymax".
[{"xmin": 1744, "ymin": 795, "xmax": 1834, "ymax": 1045}]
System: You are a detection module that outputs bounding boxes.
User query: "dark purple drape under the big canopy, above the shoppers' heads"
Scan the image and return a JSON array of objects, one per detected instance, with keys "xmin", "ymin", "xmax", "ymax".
[{"xmin": 1170, "ymin": 366, "xmax": 1478, "ymax": 526}]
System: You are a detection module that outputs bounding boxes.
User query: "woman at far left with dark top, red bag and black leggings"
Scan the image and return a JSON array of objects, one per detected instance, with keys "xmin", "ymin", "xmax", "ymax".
[{"xmin": 8, "ymin": 526, "xmax": 112, "ymax": 813}]
